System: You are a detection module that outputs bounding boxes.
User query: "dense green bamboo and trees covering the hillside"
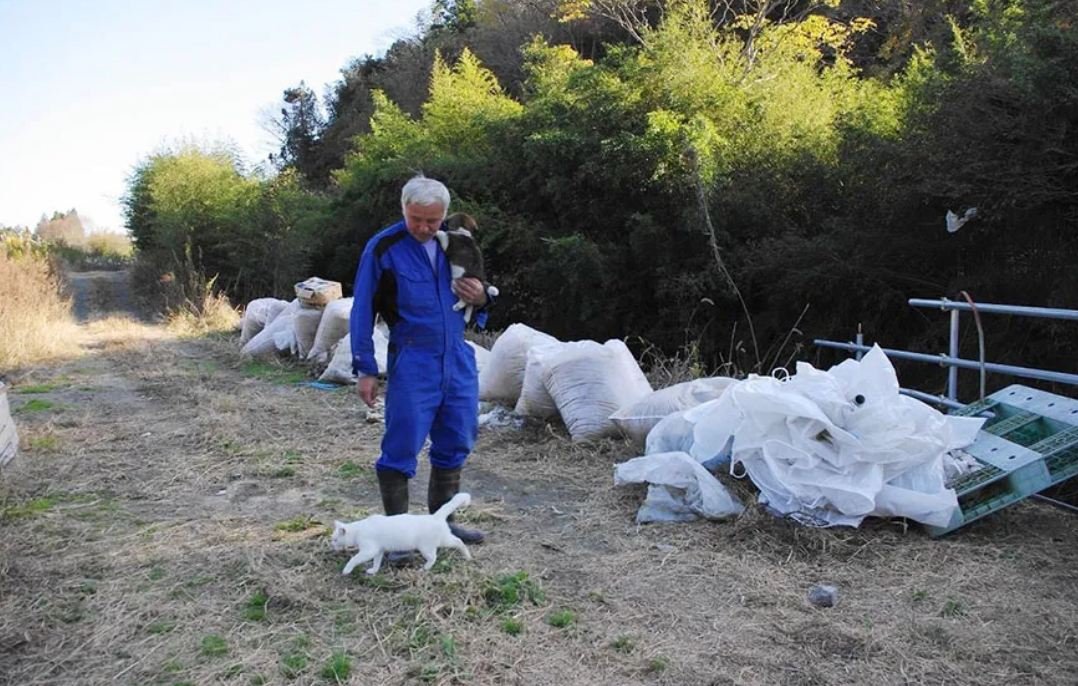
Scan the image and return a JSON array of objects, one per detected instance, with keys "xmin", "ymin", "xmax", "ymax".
[{"xmin": 118, "ymin": 0, "xmax": 1078, "ymax": 390}]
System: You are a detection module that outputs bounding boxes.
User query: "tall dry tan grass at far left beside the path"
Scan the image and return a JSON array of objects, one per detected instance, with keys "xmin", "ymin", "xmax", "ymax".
[{"xmin": 0, "ymin": 246, "xmax": 78, "ymax": 370}]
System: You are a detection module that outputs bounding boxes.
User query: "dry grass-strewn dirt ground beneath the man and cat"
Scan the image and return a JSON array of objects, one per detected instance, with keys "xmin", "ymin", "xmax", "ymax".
[{"xmin": 0, "ymin": 324, "xmax": 1078, "ymax": 686}]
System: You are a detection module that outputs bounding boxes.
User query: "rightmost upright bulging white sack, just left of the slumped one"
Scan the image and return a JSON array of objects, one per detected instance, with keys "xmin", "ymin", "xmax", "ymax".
[{"xmin": 542, "ymin": 340, "xmax": 651, "ymax": 441}]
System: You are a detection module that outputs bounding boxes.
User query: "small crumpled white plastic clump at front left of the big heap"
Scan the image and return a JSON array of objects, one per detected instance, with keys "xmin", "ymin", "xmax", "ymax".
[{"xmin": 613, "ymin": 452, "xmax": 745, "ymax": 523}]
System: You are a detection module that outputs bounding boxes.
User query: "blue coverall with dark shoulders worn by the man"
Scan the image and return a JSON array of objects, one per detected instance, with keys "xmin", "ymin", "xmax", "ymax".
[{"xmin": 349, "ymin": 221, "xmax": 486, "ymax": 479}]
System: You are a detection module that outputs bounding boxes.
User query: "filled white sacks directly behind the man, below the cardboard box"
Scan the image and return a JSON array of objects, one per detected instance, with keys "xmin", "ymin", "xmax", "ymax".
[{"xmin": 239, "ymin": 298, "xmax": 489, "ymax": 384}]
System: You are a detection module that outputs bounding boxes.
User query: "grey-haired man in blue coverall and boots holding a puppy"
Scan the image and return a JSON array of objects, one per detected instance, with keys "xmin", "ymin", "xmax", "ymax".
[{"xmin": 350, "ymin": 176, "xmax": 487, "ymax": 544}]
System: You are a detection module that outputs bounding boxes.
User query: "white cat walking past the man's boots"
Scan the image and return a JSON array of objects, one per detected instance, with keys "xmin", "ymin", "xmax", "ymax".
[{"xmin": 330, "ymin": 493, "xmax": 471, "ymax": 575}]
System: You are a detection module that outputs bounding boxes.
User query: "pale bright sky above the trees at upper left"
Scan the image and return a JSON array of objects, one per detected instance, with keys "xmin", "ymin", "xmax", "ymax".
[{"xmin": 0, "ymin": 0, "xmax": 430, "ymax": 231}]
